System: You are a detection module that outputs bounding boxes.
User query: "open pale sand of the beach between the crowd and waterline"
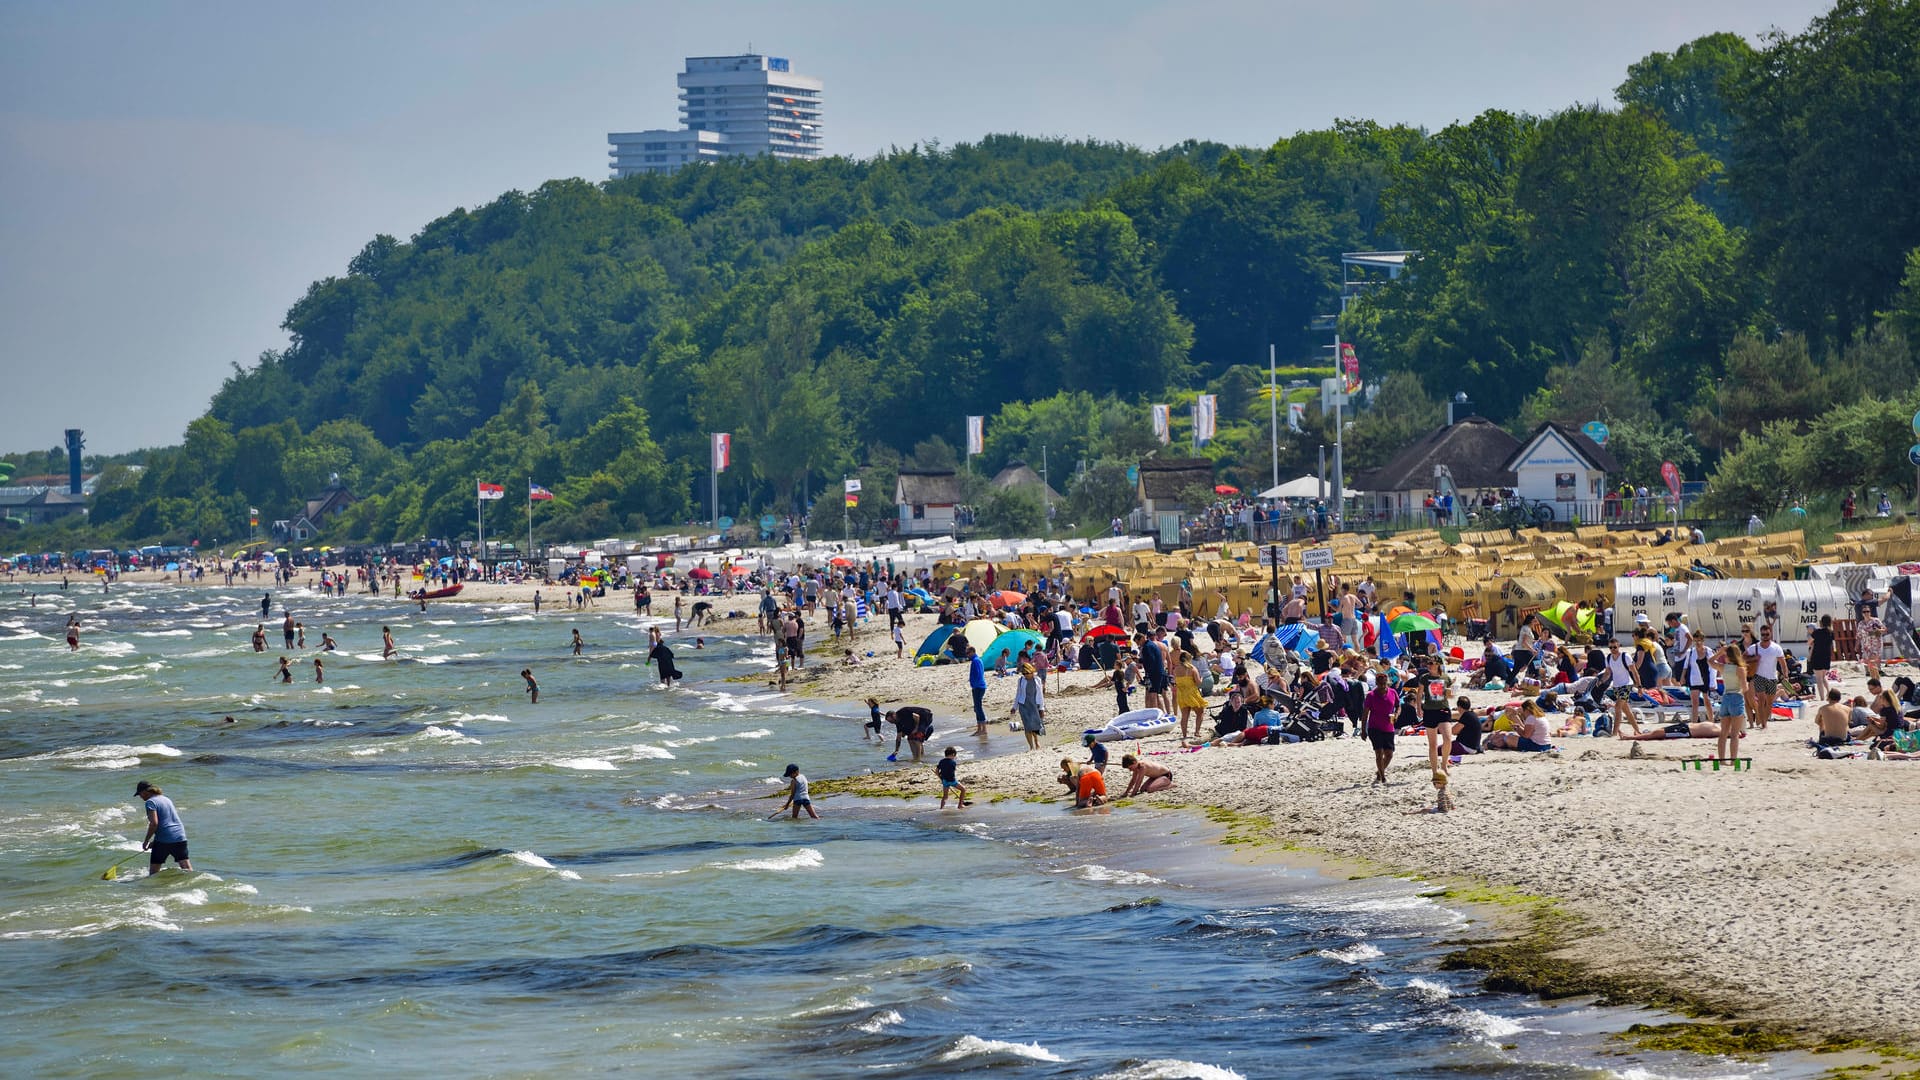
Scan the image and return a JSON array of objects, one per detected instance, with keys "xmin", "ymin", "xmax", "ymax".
[{"xmin": 764, "ymin": 617, "xmax": 1920, "ymax": 1045}]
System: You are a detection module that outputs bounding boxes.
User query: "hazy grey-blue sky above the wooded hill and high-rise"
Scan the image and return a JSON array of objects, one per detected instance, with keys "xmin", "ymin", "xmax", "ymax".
[{"xmin": 0, "ymin": 0, "xmax": 1828, "ymax": 454}]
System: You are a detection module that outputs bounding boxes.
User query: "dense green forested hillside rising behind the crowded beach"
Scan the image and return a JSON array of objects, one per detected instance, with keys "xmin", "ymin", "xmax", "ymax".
[{"xmin": 33, "ymin": 0, "xmax": 1920, "ymax": 540}]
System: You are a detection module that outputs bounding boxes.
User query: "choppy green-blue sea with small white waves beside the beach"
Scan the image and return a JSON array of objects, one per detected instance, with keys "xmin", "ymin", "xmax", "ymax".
[{"xmin": 0, "ymin": 578, "xmax": 1820, "ymax": 1080}]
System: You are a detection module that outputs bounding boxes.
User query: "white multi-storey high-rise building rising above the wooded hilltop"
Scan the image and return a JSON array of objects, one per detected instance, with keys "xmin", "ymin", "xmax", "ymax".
[{"xmin": 607, "ymin": 54, "xmax": 824, "ymax": 179}]
